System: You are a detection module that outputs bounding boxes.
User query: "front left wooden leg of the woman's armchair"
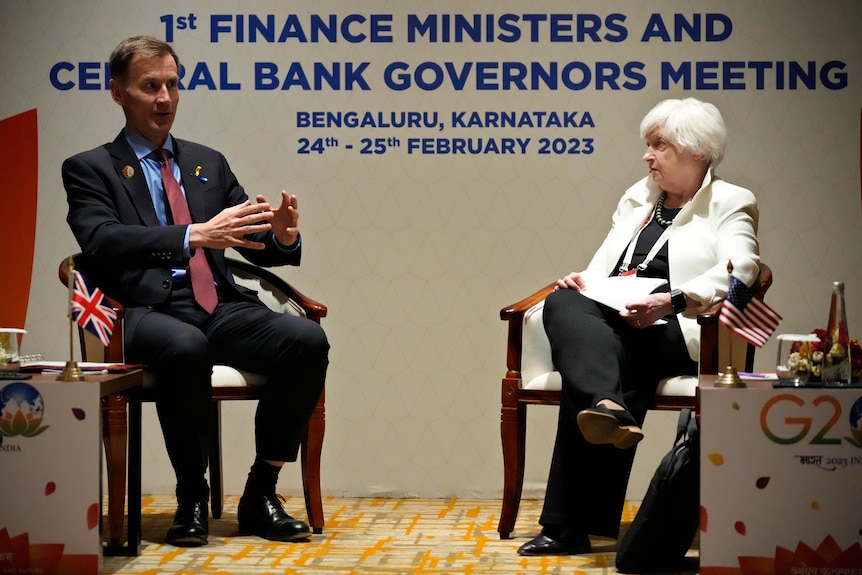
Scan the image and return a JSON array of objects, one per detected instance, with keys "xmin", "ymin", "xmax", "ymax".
[{"xmin": 497, "ymin": 379, "xmax": 527, "ymax": 539}]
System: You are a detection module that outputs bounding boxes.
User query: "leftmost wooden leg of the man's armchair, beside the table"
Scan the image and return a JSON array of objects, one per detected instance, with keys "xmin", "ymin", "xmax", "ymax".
[{"xmin": 102, "ymin": 395, "xmax": 128, "ymax": 546}]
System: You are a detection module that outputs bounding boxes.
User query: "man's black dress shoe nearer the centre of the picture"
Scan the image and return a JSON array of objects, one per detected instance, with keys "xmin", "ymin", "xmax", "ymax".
[{"xmin": 237, "ymin": 491, "xmax": 311, "ymax": 541}]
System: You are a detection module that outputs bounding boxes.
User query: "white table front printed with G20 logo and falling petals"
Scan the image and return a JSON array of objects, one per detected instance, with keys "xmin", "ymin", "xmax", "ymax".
[{"xmin": 700, "ymin": 387, "xmax": 862, "ymax": 575}]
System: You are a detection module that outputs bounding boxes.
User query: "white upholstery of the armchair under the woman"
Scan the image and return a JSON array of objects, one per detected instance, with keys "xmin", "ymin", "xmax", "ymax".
[{"xmin": 521, "ymin": 300, "xmax": 697, "ymax": 397}]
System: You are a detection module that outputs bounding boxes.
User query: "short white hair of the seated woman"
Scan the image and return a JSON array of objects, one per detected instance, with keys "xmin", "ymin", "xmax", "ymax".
[{"xmin": 640, "ymin": 98, "xmax": 727, "ymax": 168}]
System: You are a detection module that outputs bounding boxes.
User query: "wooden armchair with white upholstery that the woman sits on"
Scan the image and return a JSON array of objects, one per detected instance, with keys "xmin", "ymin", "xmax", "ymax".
[{"xmin": 497, "ymin": 263, "xmax": 772, "ymax": 539}]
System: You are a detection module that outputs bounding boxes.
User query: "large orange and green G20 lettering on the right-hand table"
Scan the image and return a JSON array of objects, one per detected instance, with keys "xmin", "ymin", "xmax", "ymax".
[{"xmin": 760, "ymin": 393, "xmax": 862, "ymax": 449}]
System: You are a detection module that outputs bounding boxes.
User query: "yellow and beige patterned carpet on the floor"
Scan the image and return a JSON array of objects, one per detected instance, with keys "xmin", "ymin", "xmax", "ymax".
[{"xmin": 102, "ymin": 496, "xmax": 697, "ymax": 575}]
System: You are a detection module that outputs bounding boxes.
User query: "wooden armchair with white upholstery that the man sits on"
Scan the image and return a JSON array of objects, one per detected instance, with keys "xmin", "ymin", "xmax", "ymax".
[{"xmin": 58, "ymin": 256, "xmax": 327, "ymax": 546}]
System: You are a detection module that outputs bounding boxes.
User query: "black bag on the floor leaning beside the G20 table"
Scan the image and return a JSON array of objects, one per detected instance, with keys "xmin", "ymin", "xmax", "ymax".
[{"xmin": 616, "ymin": 409, "xmax": 700, "ymax": 573}]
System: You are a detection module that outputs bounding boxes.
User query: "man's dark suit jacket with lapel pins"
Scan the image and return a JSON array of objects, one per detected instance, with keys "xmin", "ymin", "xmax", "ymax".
[{"xmin": 62, "ymin": 132, "xmax": 301, "ymax": 329}]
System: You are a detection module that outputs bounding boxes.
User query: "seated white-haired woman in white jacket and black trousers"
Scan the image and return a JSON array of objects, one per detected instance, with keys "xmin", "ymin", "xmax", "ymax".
[{"xmin": 518, "ymin": 98, "xmax": 759, "ymax": 555}]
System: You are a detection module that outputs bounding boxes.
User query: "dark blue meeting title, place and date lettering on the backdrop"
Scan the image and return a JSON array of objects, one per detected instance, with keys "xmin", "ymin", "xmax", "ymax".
[{"xmin": 48, "ymin": 3, "xmax": 850, "ymax": 160}]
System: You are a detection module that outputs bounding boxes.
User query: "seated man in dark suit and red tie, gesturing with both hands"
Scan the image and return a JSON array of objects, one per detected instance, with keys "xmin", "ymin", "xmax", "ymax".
[{"xmin": 62, "ymin": 36, "xmax": 329, "ymax": 546}]
